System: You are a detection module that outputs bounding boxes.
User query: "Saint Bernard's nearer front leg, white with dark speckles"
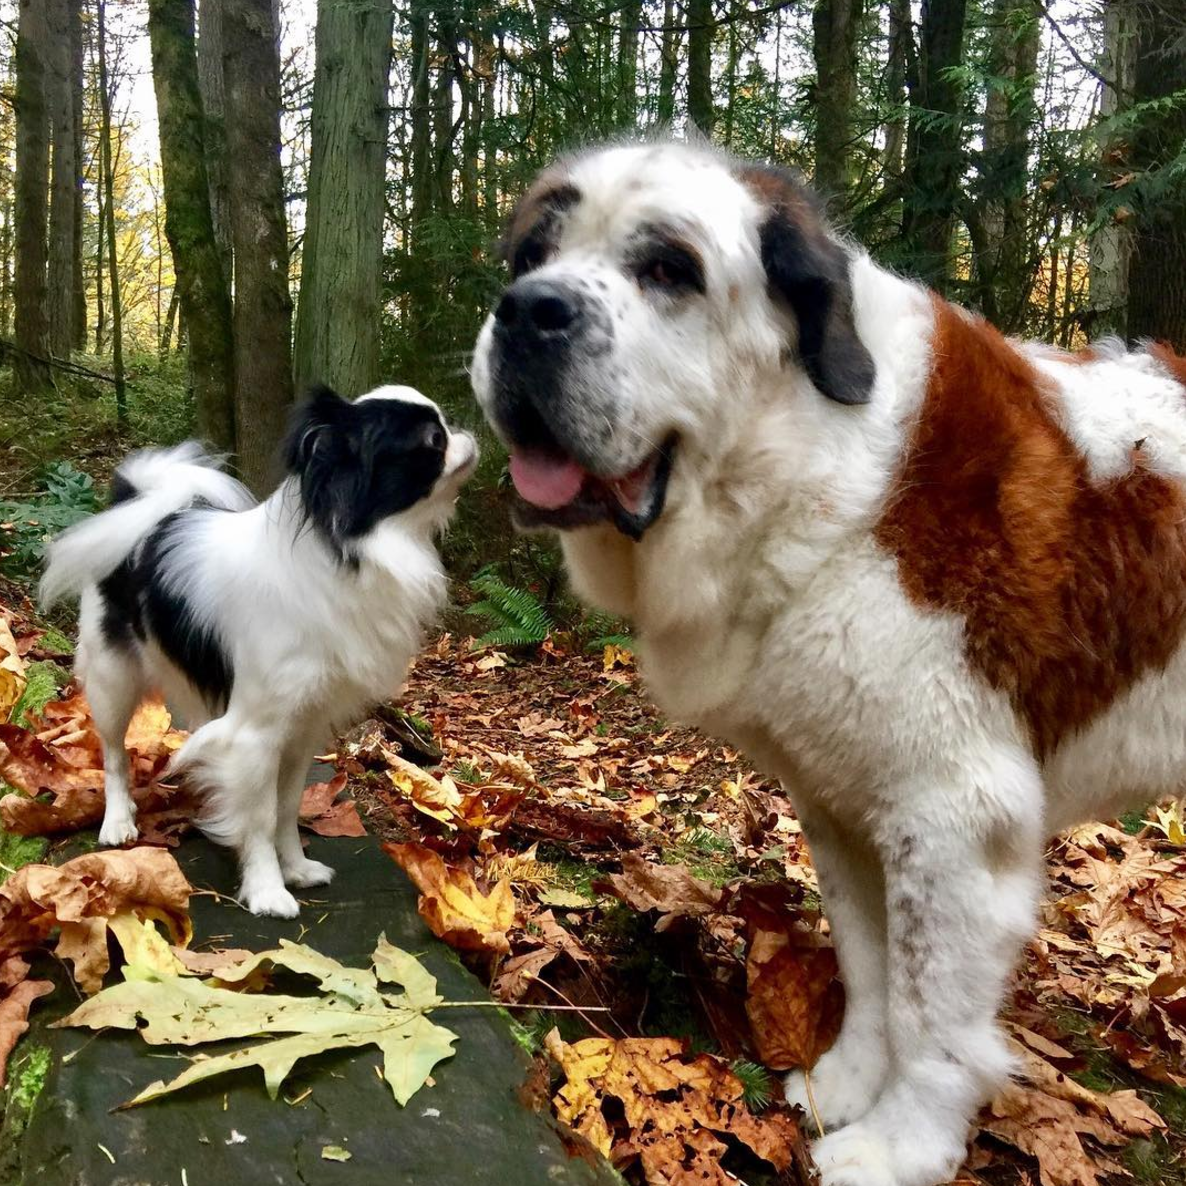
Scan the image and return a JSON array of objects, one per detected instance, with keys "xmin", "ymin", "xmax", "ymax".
[{"xmin": 814, "ymin": 753, "xmax": 1041, "ymax": 1186}]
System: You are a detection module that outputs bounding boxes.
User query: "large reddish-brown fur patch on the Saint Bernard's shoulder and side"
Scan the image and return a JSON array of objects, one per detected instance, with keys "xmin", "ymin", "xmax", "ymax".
[{"xmin": 876, "ymin": 299, "xmax": 1186, "ymax": 757}]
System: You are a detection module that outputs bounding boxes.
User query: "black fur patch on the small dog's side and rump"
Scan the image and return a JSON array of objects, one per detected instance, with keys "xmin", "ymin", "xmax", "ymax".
[{"xmin": 98, "ymin": 511, "xmax": 235, "ymax": 714}]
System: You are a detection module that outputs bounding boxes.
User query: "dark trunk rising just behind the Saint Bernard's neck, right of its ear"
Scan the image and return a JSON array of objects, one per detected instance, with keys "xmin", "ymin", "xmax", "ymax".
[{"xmin": 903, "ymin": 0, "xmax": 967, "ymax": 292}]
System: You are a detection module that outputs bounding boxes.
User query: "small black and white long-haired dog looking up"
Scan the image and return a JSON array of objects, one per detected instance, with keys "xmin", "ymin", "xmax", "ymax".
[{"xmin": 42, "ymin": 387, "xmax": 478, "ymax": 918}]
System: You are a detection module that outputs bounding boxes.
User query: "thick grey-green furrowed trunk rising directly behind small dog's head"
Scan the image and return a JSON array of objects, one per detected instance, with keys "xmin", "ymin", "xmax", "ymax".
[{"xmin": 294, "ymin": 0, "xmax": 393, "ymax": 395}]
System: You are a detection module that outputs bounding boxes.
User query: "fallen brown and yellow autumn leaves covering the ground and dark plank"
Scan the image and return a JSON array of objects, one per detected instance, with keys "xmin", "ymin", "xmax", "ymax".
[{"xmin": 0, "ymin": 597, "xmax": 1186, "ymax": 1186}]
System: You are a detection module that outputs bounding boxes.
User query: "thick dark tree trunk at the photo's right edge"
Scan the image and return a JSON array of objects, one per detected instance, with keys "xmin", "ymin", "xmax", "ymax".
[{"xmin": 1128, "ymin": 4, "xmax": 1186, "ymax": 351}]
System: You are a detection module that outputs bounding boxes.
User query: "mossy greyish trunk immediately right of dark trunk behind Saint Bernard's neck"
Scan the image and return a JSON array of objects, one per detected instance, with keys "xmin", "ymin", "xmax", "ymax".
[{"xmin": 976, "ymin": 0, "xmax": 1041, "ymax": 333}]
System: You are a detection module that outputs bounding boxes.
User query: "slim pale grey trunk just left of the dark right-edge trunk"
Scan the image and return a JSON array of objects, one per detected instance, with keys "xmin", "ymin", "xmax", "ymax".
[{"xmin": 1089, "ymin": 0, "xmax": 1137, "ymax": 337}]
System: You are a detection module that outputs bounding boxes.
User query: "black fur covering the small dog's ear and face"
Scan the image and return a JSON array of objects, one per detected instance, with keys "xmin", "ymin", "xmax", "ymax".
[{"xmin": 285, "ymin": 387, "xmax": 448, "ymax": 562}]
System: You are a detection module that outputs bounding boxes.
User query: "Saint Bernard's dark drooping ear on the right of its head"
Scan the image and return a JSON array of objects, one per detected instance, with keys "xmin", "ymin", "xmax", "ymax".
[{"xmin": 739, "ymin": 165, "xmax": 876, "ymax": 404}]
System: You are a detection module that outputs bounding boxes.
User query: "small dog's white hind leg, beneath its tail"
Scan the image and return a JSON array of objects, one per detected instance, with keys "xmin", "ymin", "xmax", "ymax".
[{"xmin": 83, "ymin": 640, "xmax": 146, "ymax": 848}]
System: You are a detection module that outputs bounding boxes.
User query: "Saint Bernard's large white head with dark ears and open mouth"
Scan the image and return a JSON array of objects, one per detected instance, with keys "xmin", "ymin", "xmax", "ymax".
[{"xmin": 473, "ymin": 142, "xmax": 874, "ymax": 538}]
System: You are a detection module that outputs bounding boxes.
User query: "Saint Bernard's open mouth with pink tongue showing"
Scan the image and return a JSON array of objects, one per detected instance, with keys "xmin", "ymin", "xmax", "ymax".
[{"xmin": 511, "ymin": 434, "xmax": 676, "ymax": 540}]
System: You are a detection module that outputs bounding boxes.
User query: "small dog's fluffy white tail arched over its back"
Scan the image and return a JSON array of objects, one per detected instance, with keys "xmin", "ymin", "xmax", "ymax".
[{"xmin": 40, "ymin": 441, "xmax": 255, "ymax": 606}]
